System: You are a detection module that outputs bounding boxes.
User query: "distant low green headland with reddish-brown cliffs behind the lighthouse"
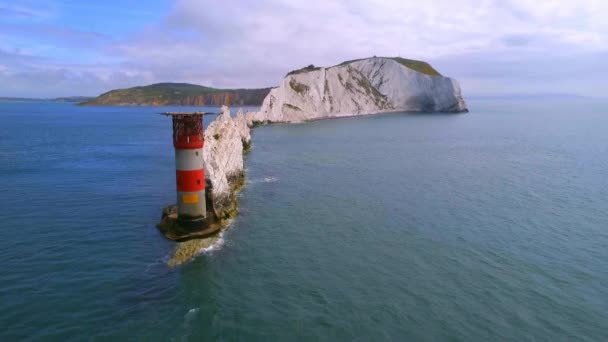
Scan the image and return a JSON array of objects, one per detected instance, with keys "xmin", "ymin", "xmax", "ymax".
[{"xmin": 80, "ymin": 83, "xmax": 270, "ymax": 106}]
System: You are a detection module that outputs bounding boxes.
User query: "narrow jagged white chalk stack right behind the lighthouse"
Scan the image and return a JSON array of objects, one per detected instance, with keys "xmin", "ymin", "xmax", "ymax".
[{"xmin": 203, "ymin": 106, "xmax": 251, "ymax": 218}]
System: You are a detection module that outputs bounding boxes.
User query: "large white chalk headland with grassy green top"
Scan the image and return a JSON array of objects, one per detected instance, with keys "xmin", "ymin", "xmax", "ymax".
[{"xmin": 247, "ymin": 57, "xmax": 467, "ymax": 123}]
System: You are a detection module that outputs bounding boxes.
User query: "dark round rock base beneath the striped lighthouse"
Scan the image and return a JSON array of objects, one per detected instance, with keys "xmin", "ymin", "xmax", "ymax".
[{"xmin": 156, "ymin": 205, "xmax": 221, "ymax": 242}]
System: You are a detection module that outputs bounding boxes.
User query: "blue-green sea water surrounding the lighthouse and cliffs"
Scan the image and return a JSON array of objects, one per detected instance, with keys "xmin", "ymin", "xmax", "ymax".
[{"xmin": 0, "ymin": 100, "xmax": 608, "ymax": 341}]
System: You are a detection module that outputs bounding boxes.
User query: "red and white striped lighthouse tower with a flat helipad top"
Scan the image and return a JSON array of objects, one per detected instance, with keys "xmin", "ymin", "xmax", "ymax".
[{"xmin": 163, "ymin": 112, "xmax": 207, "ymax": 228}]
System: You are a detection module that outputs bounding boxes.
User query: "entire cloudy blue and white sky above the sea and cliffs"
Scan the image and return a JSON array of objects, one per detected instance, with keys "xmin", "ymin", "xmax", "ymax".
[{"xmin": 0, "ymin": 0, "xmax": 608, "ymax": 97}]
